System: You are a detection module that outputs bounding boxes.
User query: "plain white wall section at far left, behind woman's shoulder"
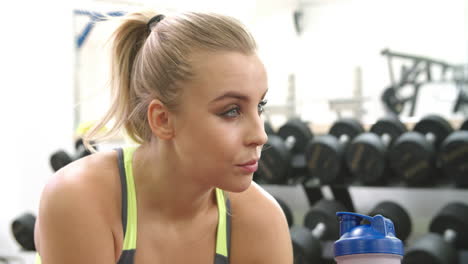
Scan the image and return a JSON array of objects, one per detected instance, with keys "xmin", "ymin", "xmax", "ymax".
[{"xmin": 0, "ymin": 0, "xmax": 73, "ymax": 255}]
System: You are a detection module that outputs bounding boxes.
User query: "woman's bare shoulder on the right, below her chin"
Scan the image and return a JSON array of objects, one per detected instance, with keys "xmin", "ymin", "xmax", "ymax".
[{"xmin": 229, "ymin": 182, "xmax": 293, "ymax": 264}]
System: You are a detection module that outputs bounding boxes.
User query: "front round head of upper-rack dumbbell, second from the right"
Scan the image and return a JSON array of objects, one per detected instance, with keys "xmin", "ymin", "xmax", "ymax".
[{"xmin": 388, "ymin": 132, "xmax": 436, "ymax": 185}]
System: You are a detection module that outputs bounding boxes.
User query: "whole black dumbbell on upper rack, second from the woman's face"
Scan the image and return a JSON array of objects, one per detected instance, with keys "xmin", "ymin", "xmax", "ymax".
[{"xmin": 305, "ymin": 118, "xmax": 364, "ymax": 184}]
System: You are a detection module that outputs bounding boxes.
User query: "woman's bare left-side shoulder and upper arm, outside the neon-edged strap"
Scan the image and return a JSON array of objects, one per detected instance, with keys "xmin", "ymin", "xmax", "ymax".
[{"xmin": 35, "ymin": 152, "xmax": 119, "ymax": 264}]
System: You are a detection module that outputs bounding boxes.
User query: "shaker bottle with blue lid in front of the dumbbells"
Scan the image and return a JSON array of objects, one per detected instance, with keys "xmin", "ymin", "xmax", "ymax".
[{"xmin": 334, "ymin": 212, "xmax": 403, "ymax": 264}]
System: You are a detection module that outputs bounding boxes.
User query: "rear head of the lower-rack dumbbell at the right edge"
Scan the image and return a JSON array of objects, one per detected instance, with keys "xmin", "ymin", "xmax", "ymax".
[{"xmin": 429, "ymin": 202, "xmax": 468, "ymax": 249}]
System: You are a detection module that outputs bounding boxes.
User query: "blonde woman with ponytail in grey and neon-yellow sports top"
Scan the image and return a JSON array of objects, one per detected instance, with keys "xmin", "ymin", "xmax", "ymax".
[{"xmin": 35, "ymin": 9, "xmax": 293, "ymax": 264}]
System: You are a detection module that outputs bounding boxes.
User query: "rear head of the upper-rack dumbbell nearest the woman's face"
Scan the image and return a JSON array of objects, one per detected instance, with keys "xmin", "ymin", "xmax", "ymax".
[{"xmin": 278, "ymin": 118, "xmax": 313, "ymax": 153}]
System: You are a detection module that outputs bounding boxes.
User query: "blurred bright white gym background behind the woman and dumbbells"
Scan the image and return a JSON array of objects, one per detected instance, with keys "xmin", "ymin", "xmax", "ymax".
[{"xmin": 0, "ymin": 0, "xmax": 468, "ymax": 263}]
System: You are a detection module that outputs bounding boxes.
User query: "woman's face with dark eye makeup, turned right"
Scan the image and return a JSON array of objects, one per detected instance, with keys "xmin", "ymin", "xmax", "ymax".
[{"xmin": 174, "ymin": 52, "xmax": 267, "ymax": 192}]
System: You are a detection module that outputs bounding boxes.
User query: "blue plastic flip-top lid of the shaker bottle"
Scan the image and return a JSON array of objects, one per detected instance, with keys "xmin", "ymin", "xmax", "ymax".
[{"xmin": 335, "ymin": 212, "xmax": 403, "ymax": 257}]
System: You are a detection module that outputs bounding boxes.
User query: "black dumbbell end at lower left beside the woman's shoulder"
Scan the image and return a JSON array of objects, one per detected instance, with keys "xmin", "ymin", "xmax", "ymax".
[{"xmin": 11, "ymin": 213, "xmax": 36, "ymax": 251}]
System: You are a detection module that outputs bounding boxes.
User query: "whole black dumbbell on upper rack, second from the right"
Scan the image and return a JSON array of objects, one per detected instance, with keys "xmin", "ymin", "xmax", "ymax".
[{"xmin": 389, "ymin": 115, "xmax": 453, "ymax": 185}]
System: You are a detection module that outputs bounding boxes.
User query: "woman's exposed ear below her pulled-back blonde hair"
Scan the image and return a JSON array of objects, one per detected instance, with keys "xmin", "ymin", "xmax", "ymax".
[{"xmin": 147, "ymin": 99, "xmax": 174, "ymax": 140}]
